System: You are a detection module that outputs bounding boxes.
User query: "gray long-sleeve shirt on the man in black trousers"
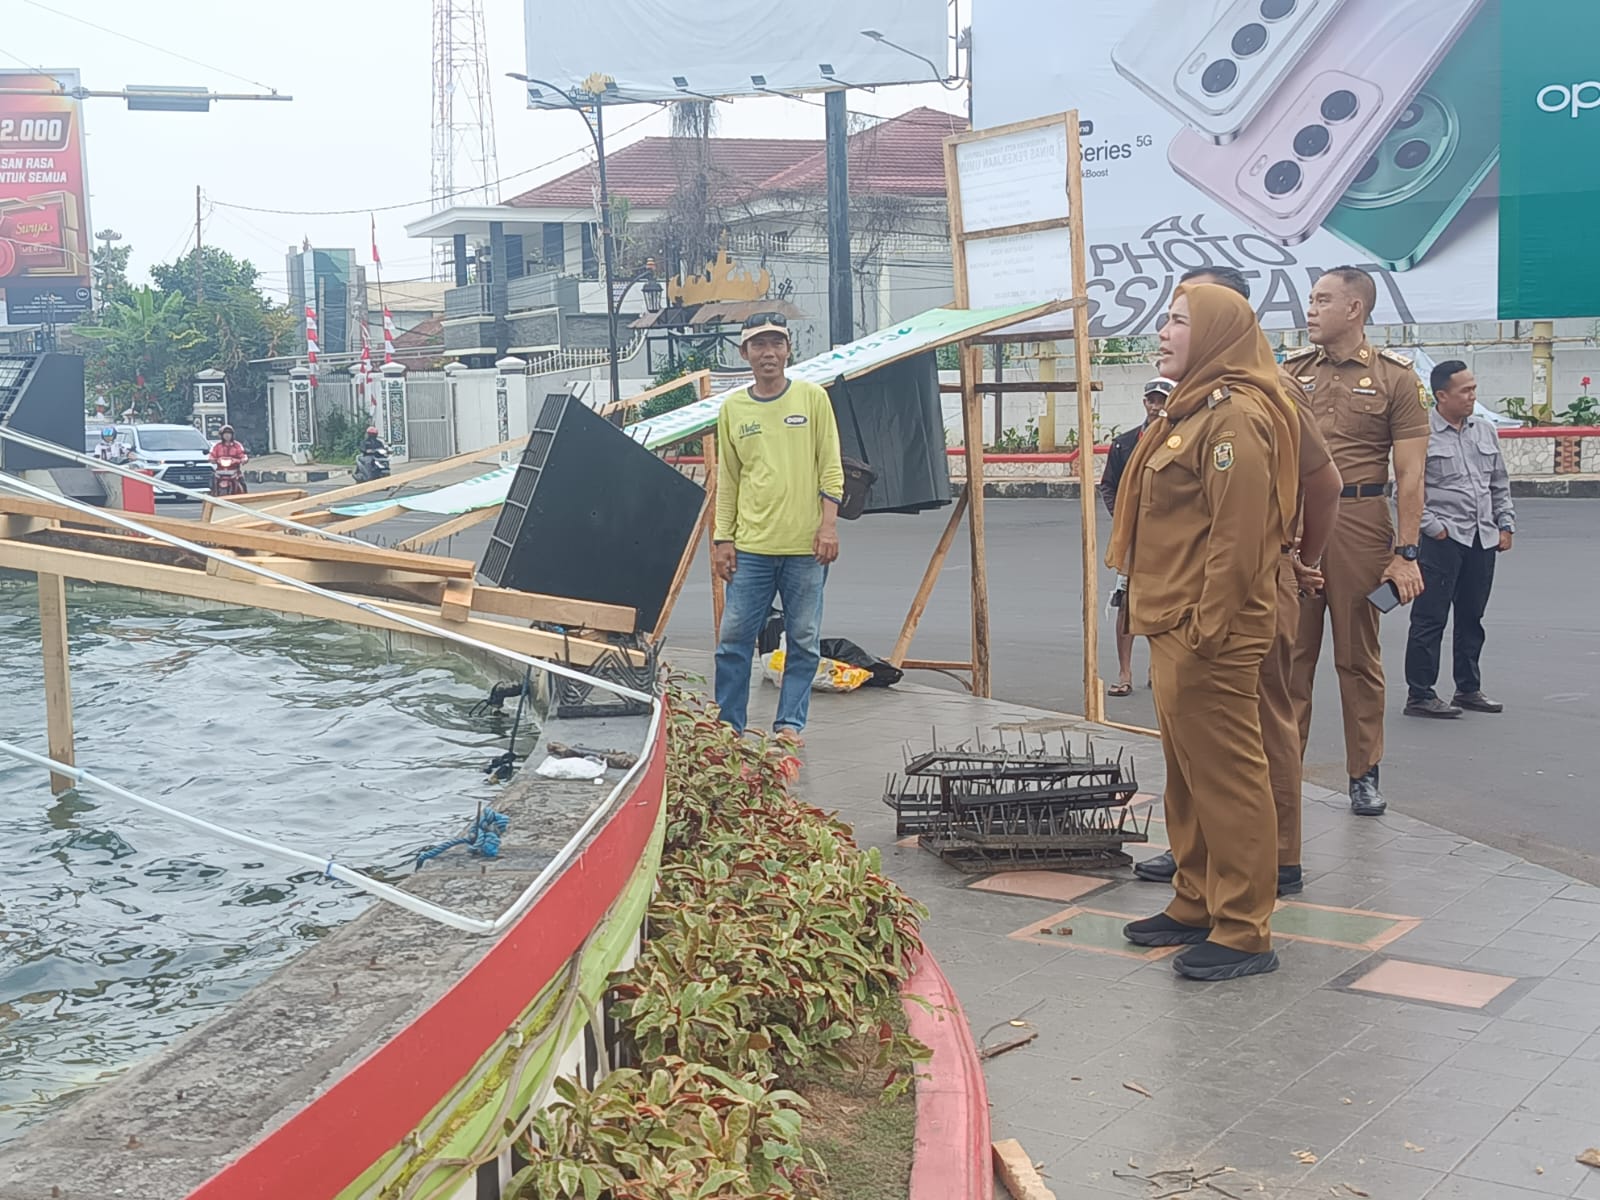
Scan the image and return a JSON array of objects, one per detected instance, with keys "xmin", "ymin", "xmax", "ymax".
[{"xmin": 1422, "ymin": 408, "xmax": 1517, "ymax": 550}]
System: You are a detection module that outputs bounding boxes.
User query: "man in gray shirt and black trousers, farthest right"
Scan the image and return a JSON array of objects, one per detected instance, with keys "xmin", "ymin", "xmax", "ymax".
[{"xmin": 1405, "ymin": 362, "xmax": 1517, "ymax": 718}]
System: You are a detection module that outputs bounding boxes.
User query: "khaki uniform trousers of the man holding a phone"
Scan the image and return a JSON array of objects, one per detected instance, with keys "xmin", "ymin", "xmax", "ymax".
[{"xmin": 1290, "ymin": 496, "xmax": 1394, "ymax": 779}]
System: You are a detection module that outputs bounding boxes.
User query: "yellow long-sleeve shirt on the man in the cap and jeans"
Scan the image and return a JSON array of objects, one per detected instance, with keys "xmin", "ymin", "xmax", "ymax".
[{"xmin": 715, "ymin": 379, "xmax": 845, "ymax": 555}]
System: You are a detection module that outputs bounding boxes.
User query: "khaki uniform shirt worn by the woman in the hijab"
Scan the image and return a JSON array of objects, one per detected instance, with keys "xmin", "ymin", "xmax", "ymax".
[{"xmin": 1122, "ymin": 389, "xmax": 1288, "ymax": 658}]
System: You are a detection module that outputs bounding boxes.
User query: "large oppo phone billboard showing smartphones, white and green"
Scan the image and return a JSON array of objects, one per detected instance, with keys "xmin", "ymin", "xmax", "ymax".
[{"xmin": 973, "ymin": 0, "xmax": 1600, "ymax": 338}]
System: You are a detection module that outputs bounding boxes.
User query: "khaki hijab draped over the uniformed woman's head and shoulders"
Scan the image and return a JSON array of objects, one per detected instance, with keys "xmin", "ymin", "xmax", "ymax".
[{"xmin": 1106, "ymin": 283, "xmax": 1301, "ymax": 574}]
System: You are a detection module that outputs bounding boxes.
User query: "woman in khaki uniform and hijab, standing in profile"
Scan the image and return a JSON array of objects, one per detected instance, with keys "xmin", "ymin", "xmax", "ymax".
[{"xmin": 1107, "ymin": 283, "xmax": 1299, "ymax": 979}]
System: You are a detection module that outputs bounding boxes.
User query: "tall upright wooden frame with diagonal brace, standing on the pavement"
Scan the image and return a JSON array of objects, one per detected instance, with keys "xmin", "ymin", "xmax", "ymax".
[{"xmin": 921, "ymin": 110, "xmax": 1106, "ymax": 722}]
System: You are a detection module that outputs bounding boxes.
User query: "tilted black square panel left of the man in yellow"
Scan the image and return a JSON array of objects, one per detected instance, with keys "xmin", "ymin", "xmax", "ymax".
[{"xmin": 478, "ymin": 394, "xmax": 706, "ymax": 630}]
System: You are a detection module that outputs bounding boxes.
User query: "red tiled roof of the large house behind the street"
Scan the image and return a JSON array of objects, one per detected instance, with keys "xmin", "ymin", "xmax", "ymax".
[{"xmin": 509, "ymin": 107, "xmax": 966, "ymax": 208}]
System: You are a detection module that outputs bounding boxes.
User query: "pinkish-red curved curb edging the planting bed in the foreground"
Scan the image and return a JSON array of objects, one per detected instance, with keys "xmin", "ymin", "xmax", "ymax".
[{"xmin": 901, "ymin": 949, "xmax": 995, "ymax": 1200}]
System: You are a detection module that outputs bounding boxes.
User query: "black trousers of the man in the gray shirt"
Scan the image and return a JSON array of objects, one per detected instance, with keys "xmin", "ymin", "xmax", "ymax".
[{"xmin": 1405, "ymin": 538, "xmax": 1499, "ymax": 699}]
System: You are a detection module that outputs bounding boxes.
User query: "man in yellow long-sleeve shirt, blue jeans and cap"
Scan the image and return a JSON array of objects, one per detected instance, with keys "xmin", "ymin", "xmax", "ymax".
[{"xmin": 712, "ymin": 312, "xmax": 845, "ymax": 744}]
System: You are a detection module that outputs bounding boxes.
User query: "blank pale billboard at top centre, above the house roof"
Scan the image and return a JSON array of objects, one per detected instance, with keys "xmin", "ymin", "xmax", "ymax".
[{"xmin": 523, "ymin": 0, "xmax": 950, "ymax": 101}]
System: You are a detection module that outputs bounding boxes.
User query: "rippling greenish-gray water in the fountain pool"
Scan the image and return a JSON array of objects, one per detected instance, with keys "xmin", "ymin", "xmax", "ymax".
[{"xmin": 0, "ymin": 581, "xmax": 544, "ymax": 1141}]
